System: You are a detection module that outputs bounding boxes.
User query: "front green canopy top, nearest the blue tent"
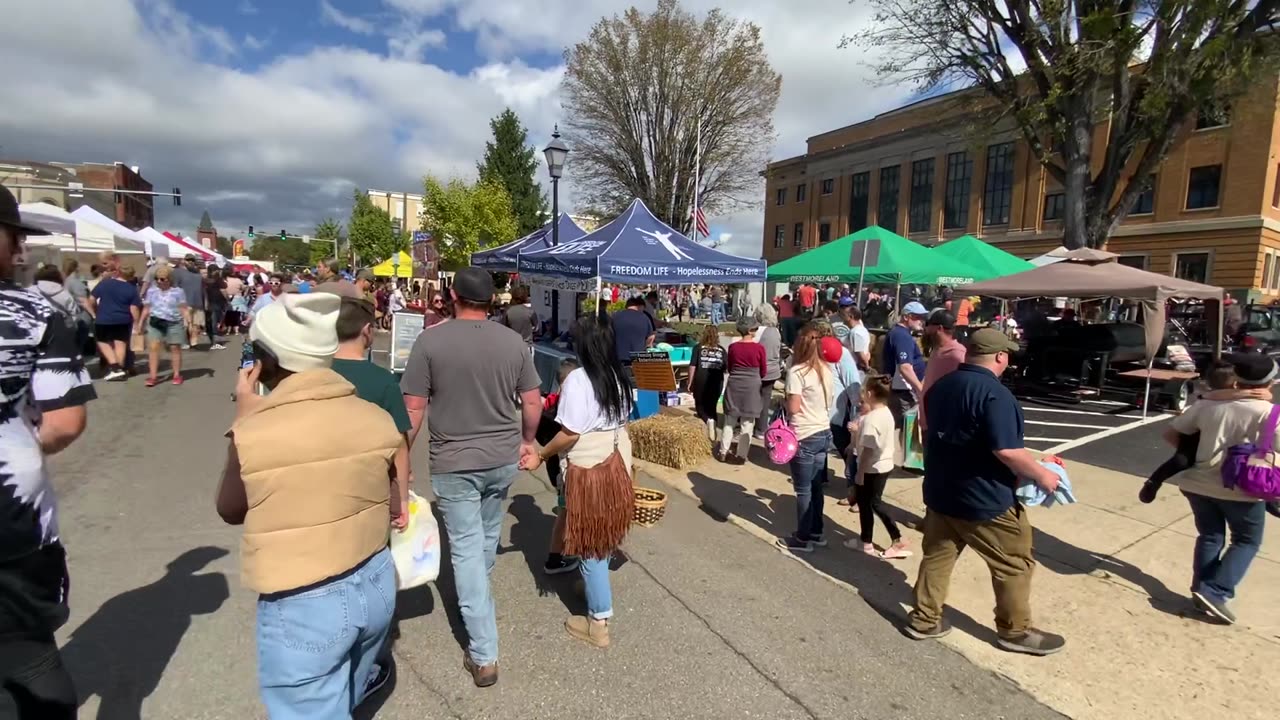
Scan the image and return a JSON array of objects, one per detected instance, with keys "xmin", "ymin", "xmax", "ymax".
[{"xmin": 767, "ymin": 225, "xmax": 987, "ymax": 284}]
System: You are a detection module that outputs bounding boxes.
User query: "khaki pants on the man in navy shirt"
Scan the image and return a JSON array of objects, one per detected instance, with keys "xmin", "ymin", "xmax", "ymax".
[{"xmin": 910, "ymin": 505, "xmax": 1036, "ymax": 638}]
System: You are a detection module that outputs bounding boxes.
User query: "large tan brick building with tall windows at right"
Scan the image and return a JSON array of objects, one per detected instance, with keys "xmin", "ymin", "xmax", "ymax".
[{"xmin": 762, "ymin": 73, "xmax": 1280, "ymax": 297}]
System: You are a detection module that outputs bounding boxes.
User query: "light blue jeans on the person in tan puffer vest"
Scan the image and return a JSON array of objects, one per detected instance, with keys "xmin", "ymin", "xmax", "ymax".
[{"xmin": 257, "ymin": 548, "xmax": 396, "ymax": 720}]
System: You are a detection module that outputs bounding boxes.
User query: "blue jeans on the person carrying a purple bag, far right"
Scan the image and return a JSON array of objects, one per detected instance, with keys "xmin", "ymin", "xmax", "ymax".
[{"xmin": 1183, "ymin": 492, "xmax": 1267, "ymax": 601}]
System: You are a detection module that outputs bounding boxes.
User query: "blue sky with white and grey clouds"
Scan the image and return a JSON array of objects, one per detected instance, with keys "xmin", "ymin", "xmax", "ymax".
[{"xmin": 0, "ymin": 0, "xmax": 908, "ymax": 256}]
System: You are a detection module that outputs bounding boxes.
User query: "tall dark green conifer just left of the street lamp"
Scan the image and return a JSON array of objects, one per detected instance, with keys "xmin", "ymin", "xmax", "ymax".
[{"xmin": 476, "ymin": 108, "xmax": 548, "ymax": 236}]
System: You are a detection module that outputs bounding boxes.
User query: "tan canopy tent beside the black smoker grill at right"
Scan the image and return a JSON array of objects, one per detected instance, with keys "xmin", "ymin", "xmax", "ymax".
[{"xmin": 956, "ymin": 249, "xmax": 1224, "ymax": 363}]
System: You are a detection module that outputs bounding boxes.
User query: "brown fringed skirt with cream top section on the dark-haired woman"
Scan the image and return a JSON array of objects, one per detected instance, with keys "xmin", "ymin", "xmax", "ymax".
[{"xmin": 564, "ymin": 428, "xmax": 635, "ymax": 559}]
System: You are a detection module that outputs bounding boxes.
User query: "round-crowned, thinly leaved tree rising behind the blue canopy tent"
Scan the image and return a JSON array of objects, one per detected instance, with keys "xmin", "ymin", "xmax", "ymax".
[{"xmin": 563, "ymin": 0, "xmax": 782, "ymax": 232}]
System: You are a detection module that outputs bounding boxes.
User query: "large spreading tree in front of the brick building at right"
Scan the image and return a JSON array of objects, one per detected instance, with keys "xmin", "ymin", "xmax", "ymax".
[{"xmin": 845, "ymin": 0, "xmax": 1280, "ymax": 247}]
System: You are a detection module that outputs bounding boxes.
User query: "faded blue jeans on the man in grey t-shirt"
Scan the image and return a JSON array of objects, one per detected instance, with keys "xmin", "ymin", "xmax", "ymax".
[{"xmin": 431, "ymin": 465, "xmax": 517, "ymax": 666}]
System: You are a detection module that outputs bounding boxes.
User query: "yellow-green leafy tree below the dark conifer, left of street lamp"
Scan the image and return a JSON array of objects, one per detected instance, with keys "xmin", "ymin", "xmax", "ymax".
[{"xmin": 422, "ymin": 176, "xmax": 517, "ymax": 268}]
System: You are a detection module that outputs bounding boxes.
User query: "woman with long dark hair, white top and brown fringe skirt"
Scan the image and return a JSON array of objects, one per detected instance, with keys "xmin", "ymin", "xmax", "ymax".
[{"xmin": 521, "ymin": 316, "xmax": 635, "ymax": 647}]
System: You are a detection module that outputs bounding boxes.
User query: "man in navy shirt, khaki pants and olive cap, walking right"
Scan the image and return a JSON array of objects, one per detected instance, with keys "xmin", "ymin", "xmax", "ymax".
[{"xmin": 904, "ymin": 328, "xmax": 1065, "ymax": 655}]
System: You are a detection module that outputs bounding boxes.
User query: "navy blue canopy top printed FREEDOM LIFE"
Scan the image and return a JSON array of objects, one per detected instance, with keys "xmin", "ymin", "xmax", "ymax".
[{"xmin": 517, "ymin": 200, "xmax": 764, "ymax": 291}]
